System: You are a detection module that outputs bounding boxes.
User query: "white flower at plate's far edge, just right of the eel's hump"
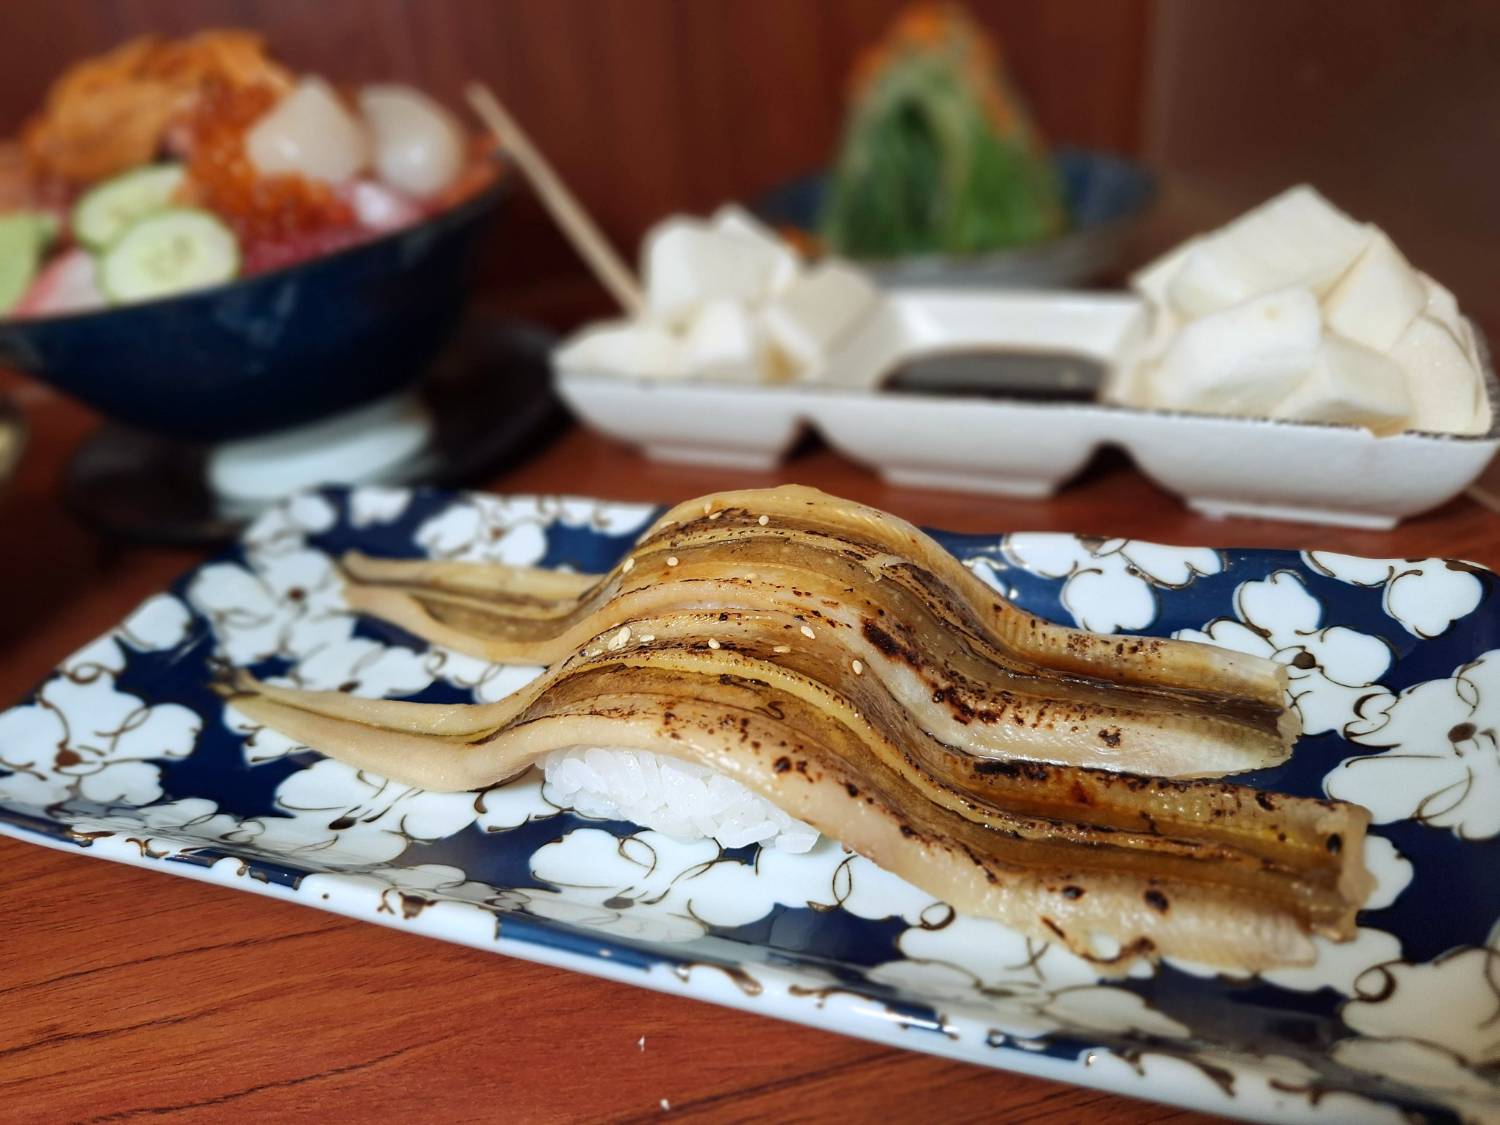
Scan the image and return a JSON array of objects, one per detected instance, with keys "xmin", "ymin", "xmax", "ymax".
[{"xmin": 969, "ymin": 533, "xmax": 1224, "ymax": 633}]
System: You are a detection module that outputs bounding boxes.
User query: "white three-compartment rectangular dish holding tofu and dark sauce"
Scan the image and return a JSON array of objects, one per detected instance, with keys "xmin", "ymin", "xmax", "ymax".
[{"xmin": 557, "ymin": 290, "xmax": 1500, "ymax": 528}]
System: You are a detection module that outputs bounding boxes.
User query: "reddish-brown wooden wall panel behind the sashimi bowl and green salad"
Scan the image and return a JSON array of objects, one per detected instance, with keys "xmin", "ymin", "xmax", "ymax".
[{"xmin": 0, "ymin": 0, "xmax": 1149, "ymax": 318}]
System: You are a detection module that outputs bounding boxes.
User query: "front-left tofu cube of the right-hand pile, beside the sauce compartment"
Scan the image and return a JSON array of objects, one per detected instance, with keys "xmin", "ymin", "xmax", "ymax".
[{"xmin": 1152, "ymin": 288, "xmax": 1323, "ymax": 417}]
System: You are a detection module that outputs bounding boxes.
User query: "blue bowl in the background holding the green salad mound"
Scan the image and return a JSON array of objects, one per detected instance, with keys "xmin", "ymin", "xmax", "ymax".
[{"xmin": 755, "ymin": 149, "xmax": 1157, "ymax": 288}]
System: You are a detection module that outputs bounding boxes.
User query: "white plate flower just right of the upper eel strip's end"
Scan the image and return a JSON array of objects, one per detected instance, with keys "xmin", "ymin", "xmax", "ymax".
[{"xmin": 1173, "ymin": 570, "xmax": 1391, "ymax": 735}]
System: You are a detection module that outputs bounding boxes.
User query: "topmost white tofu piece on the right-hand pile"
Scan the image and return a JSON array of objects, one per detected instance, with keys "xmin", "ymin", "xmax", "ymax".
[{"xmin": 1167, "ymin": 185, "xmax": 1376, "ymax": 317}]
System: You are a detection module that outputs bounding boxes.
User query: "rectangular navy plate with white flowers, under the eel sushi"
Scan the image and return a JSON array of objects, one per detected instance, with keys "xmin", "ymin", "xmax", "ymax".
[{"xmin": 0, "ymin": 489, "xmax": 1500, "ymax": 1122}]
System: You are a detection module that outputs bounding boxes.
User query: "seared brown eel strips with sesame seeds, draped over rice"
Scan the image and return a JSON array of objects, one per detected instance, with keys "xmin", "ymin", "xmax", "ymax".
[{"xmin": 224, "ymin": 488, "xmax": 1371, "ymax": 969}]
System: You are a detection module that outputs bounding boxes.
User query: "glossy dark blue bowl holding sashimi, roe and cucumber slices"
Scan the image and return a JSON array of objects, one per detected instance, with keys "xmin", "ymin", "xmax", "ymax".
[{"xmin": 0, "ymin": 180, "xmax": 509, "ymax": 441}]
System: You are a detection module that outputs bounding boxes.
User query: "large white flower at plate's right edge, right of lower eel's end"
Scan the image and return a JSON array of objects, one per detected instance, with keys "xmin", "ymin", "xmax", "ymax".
[{"xmin": 1323, "ymin": 650, "xmax": 1500, "ymax": 840}]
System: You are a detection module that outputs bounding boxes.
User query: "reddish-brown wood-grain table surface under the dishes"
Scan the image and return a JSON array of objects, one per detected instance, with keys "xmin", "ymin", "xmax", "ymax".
[{"xmin": 0, "ymin": 375, "xmax": 1500, "ymax": 1125}]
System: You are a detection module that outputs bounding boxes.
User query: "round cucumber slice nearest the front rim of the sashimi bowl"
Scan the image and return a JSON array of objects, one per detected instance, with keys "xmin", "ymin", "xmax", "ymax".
[{"xmin": 99, "ymin": 207, "xmax": 240, "ymax": 303}]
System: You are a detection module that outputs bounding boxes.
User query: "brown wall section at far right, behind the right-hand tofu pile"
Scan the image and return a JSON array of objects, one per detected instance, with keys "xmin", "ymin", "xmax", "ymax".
[{"xmin": 1146, "ymin": 0, "xmax": 1500, "ymax": 338}]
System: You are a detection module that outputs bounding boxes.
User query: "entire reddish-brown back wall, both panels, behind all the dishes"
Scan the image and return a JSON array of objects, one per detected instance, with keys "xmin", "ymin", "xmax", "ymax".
[{"xmin": 0, "ymin": 0, "xmax": 1500, "ymax": 336}]
